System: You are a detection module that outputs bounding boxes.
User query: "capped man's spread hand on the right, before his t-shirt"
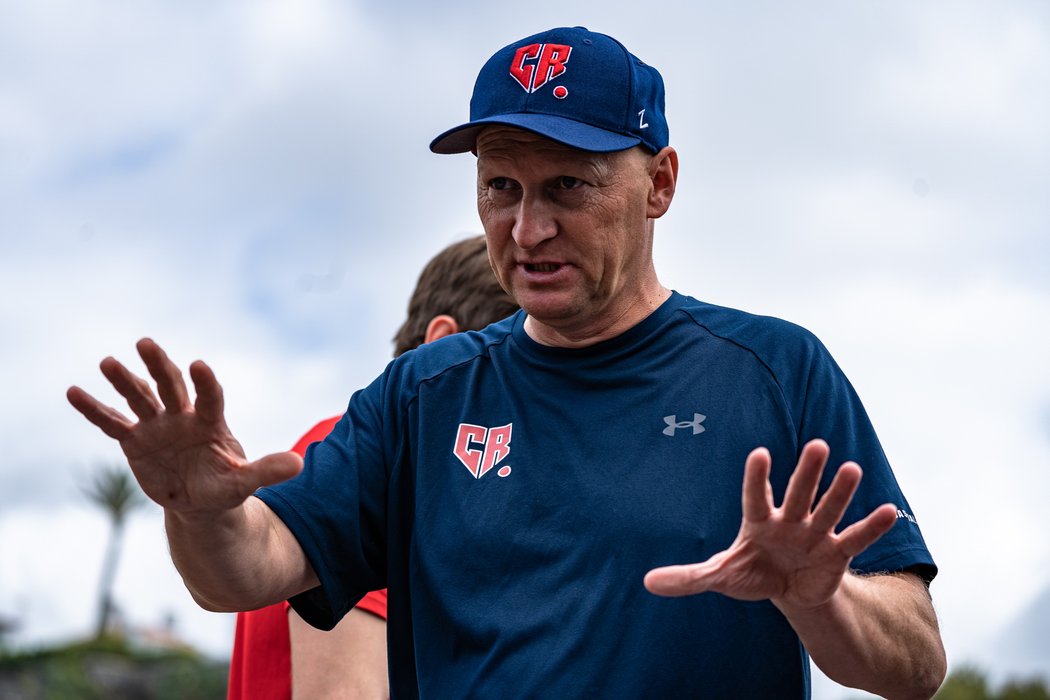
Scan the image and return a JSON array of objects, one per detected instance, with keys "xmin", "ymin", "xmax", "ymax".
[{"xmin": 645, "ymin": 440, "xmax": 897, "ymax": 610}]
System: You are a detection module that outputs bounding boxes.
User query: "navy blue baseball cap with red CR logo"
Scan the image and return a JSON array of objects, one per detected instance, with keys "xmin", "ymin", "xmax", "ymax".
[{"xmin": 431, "ymin": 26, "xmax": 668, "ymax": 153}]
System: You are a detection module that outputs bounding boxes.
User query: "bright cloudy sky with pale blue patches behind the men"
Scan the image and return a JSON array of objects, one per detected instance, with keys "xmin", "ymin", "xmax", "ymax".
[{"xmin": 0, "ymin": 0, "xmax": 1050, "ymax": 698}]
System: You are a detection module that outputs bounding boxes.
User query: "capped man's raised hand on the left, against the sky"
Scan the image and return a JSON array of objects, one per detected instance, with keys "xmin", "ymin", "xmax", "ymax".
[{"xmin": 66, "ymin": 338, "xmax": 302, "ymax": 514}]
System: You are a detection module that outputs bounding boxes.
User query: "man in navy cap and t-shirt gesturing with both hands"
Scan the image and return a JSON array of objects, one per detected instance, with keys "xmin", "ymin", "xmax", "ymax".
[{"xmin": 69, "ymin": 27, "xmax": 945, "ymax": 698}]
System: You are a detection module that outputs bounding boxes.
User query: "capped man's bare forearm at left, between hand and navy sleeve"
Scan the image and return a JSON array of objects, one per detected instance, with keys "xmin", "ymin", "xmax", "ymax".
[{"xmin": 164, "ymin": 497, "xmax": 317, "ymax": 612}]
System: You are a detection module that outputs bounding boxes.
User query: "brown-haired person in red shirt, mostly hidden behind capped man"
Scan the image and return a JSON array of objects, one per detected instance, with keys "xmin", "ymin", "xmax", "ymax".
[{"xmin": 228, "ymin": 236, "xmax": 518, "ymax": 700}]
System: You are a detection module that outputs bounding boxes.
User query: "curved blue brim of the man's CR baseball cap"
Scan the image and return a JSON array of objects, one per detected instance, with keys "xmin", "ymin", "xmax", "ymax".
[{"xmin": 431, "ymin": 112, "xmax": 642, "ymax": 153}]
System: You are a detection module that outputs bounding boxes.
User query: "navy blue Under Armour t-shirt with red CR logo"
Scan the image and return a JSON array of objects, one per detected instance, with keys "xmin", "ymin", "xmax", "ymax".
[{"xmin": 258, "ymin": 293, "xmax": 936, "ymax": 698}]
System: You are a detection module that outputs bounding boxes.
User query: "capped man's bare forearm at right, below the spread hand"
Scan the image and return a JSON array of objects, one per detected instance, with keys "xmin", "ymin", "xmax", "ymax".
[{"xmin": 778, "ymin": 573, "xmax": 947, "ymax": 700}]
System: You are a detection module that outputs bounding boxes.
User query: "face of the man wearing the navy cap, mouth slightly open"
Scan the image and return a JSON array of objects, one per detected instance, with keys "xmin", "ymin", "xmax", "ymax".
[{"xmin": 477, "ymin": 126, "xmax": 655, "ymax": 338}]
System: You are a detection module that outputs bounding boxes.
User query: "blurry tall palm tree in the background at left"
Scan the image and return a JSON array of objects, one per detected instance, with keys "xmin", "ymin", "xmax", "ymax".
[{"xmin": 84, "ymin": 465, "xmax": 147, "ymax": 639}]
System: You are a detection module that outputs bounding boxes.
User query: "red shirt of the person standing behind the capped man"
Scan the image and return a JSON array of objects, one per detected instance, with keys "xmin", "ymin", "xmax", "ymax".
[{"xmin": 226, "ymin": 416, "xmax": 386, "ymax": 700}]
